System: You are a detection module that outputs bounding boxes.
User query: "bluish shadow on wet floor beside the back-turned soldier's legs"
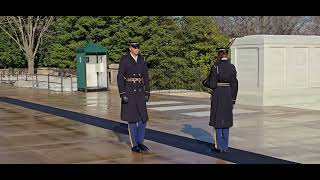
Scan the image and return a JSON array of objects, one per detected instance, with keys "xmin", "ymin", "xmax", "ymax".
[{"xmin": 181, "ymin": 124, "xmax": 213, "ymax": 143}]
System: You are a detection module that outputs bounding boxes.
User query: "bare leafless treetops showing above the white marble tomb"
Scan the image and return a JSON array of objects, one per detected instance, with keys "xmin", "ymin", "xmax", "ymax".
[{"xmin": 214, "ymin": 16, "xmax": 310, "ymax": 37}]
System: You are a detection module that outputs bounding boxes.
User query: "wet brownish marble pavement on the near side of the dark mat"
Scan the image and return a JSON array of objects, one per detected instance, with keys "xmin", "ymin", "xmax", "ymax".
[{"xmin": 0, "ymin": 103, "xmax": 230, "ymax": 164}]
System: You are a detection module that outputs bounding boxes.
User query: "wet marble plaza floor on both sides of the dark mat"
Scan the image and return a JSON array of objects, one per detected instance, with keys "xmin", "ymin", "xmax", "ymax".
[{"xmin": 0, "ymin": 84, "xmax": 320, "ymax": 164}]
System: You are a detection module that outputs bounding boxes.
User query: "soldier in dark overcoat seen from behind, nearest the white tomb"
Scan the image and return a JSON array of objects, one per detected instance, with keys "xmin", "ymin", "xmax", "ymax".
[{"xmin": 204, "ymin": 48, "xmax": 238, "ymax": 153}]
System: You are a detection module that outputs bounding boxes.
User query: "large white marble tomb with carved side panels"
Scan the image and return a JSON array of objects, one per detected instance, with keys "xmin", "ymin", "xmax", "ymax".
[{"xmin": 231, "ymin": 35, "xmax": 320, "ymax": 106}]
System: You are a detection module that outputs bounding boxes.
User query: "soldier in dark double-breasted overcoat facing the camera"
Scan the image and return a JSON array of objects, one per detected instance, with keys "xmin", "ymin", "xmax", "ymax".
[{"xmin": 117, "ymin": 43, "xmax": 150, "ymax": 152}]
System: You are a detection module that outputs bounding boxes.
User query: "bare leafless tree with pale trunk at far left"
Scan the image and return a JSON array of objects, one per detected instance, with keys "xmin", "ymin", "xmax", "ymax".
[{"xmin": 0, "ymin": 16, "xmax": 54, "ymax": 74}]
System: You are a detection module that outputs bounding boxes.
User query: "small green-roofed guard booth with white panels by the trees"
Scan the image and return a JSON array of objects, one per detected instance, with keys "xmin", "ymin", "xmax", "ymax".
[{"xmin": 76, "ymin": 41, "xmax": 109, "ymax": 92}]
